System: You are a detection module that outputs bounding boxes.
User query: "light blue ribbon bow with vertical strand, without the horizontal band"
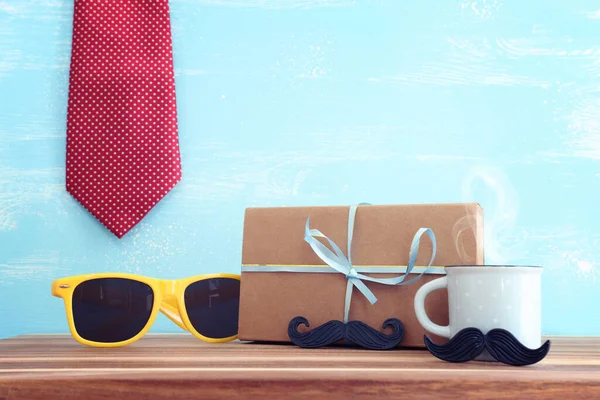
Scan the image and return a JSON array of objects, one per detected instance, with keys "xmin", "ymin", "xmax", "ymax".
[{"xmin": 304, "ymin": 205, "xmax": 436, "ymax": 323}]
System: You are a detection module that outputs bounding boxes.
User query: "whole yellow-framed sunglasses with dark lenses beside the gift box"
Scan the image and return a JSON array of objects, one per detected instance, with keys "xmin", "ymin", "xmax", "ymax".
[{"xmin": 52, "ymin": 273, "xmax": 240, "ymax": 347}]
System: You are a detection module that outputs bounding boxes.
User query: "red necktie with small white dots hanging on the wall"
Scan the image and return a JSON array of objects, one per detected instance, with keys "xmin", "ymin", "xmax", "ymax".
[{"xmin": 66, "ymin": 0, "xmax": 181, "ymax": 238}]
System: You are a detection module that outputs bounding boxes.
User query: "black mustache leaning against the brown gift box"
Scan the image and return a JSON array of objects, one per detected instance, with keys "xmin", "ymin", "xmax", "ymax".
[{"xmin": 288, "ymin": 317, "xmax": 404, "ymax": 350}]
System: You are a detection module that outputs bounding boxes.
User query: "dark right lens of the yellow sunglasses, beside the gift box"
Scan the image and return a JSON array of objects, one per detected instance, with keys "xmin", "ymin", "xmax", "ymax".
[{"xmin": 184, "ymin": 278, "xmax": 240, "ymax": 339}]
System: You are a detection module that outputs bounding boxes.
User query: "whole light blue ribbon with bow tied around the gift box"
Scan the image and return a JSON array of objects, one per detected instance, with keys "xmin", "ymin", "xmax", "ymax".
[{"xmin": 242, "ymin": 205, "xmax": 444, "ymax": 323}]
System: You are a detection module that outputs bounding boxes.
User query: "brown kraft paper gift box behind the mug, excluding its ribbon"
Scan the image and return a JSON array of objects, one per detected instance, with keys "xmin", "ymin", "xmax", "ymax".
[{"xmin": 239, "ymin": 203, "xmax": 484, "ymax": 347}]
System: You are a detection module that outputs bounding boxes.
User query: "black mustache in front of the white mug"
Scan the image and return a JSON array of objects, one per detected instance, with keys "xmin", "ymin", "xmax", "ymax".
[{"xmin": 425, "ymin": 328, "xmax": 550, "ymax": 366}]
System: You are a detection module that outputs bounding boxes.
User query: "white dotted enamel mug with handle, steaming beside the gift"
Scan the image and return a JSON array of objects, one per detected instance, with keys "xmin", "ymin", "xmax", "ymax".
[{"xmin": 415, "ymin": 265, "xmax": 542, "ymax": 360}]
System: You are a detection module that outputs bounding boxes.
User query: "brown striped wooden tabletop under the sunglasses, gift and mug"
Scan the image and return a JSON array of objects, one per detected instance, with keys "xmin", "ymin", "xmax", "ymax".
[{"xmin": 0, "ymin": 335, "xmax": 600, "ymax": 400}]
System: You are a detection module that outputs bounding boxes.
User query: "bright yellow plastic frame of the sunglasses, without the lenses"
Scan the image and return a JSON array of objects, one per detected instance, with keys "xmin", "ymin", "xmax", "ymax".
[{"xmin": 52, "ymin": 273, "xmax": 240, "ymax": 347}]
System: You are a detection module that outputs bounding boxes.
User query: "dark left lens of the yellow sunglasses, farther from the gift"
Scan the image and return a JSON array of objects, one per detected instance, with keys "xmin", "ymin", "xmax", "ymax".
[{"xmin": 73, "ymin": 278, "xmax": 154, "ymax": 343}]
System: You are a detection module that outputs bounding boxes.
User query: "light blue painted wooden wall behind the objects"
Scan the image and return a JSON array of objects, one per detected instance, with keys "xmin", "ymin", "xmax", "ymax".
[{"xmin": 0, "ymin": 0, "xmax": 600, "ymax": 337}]
